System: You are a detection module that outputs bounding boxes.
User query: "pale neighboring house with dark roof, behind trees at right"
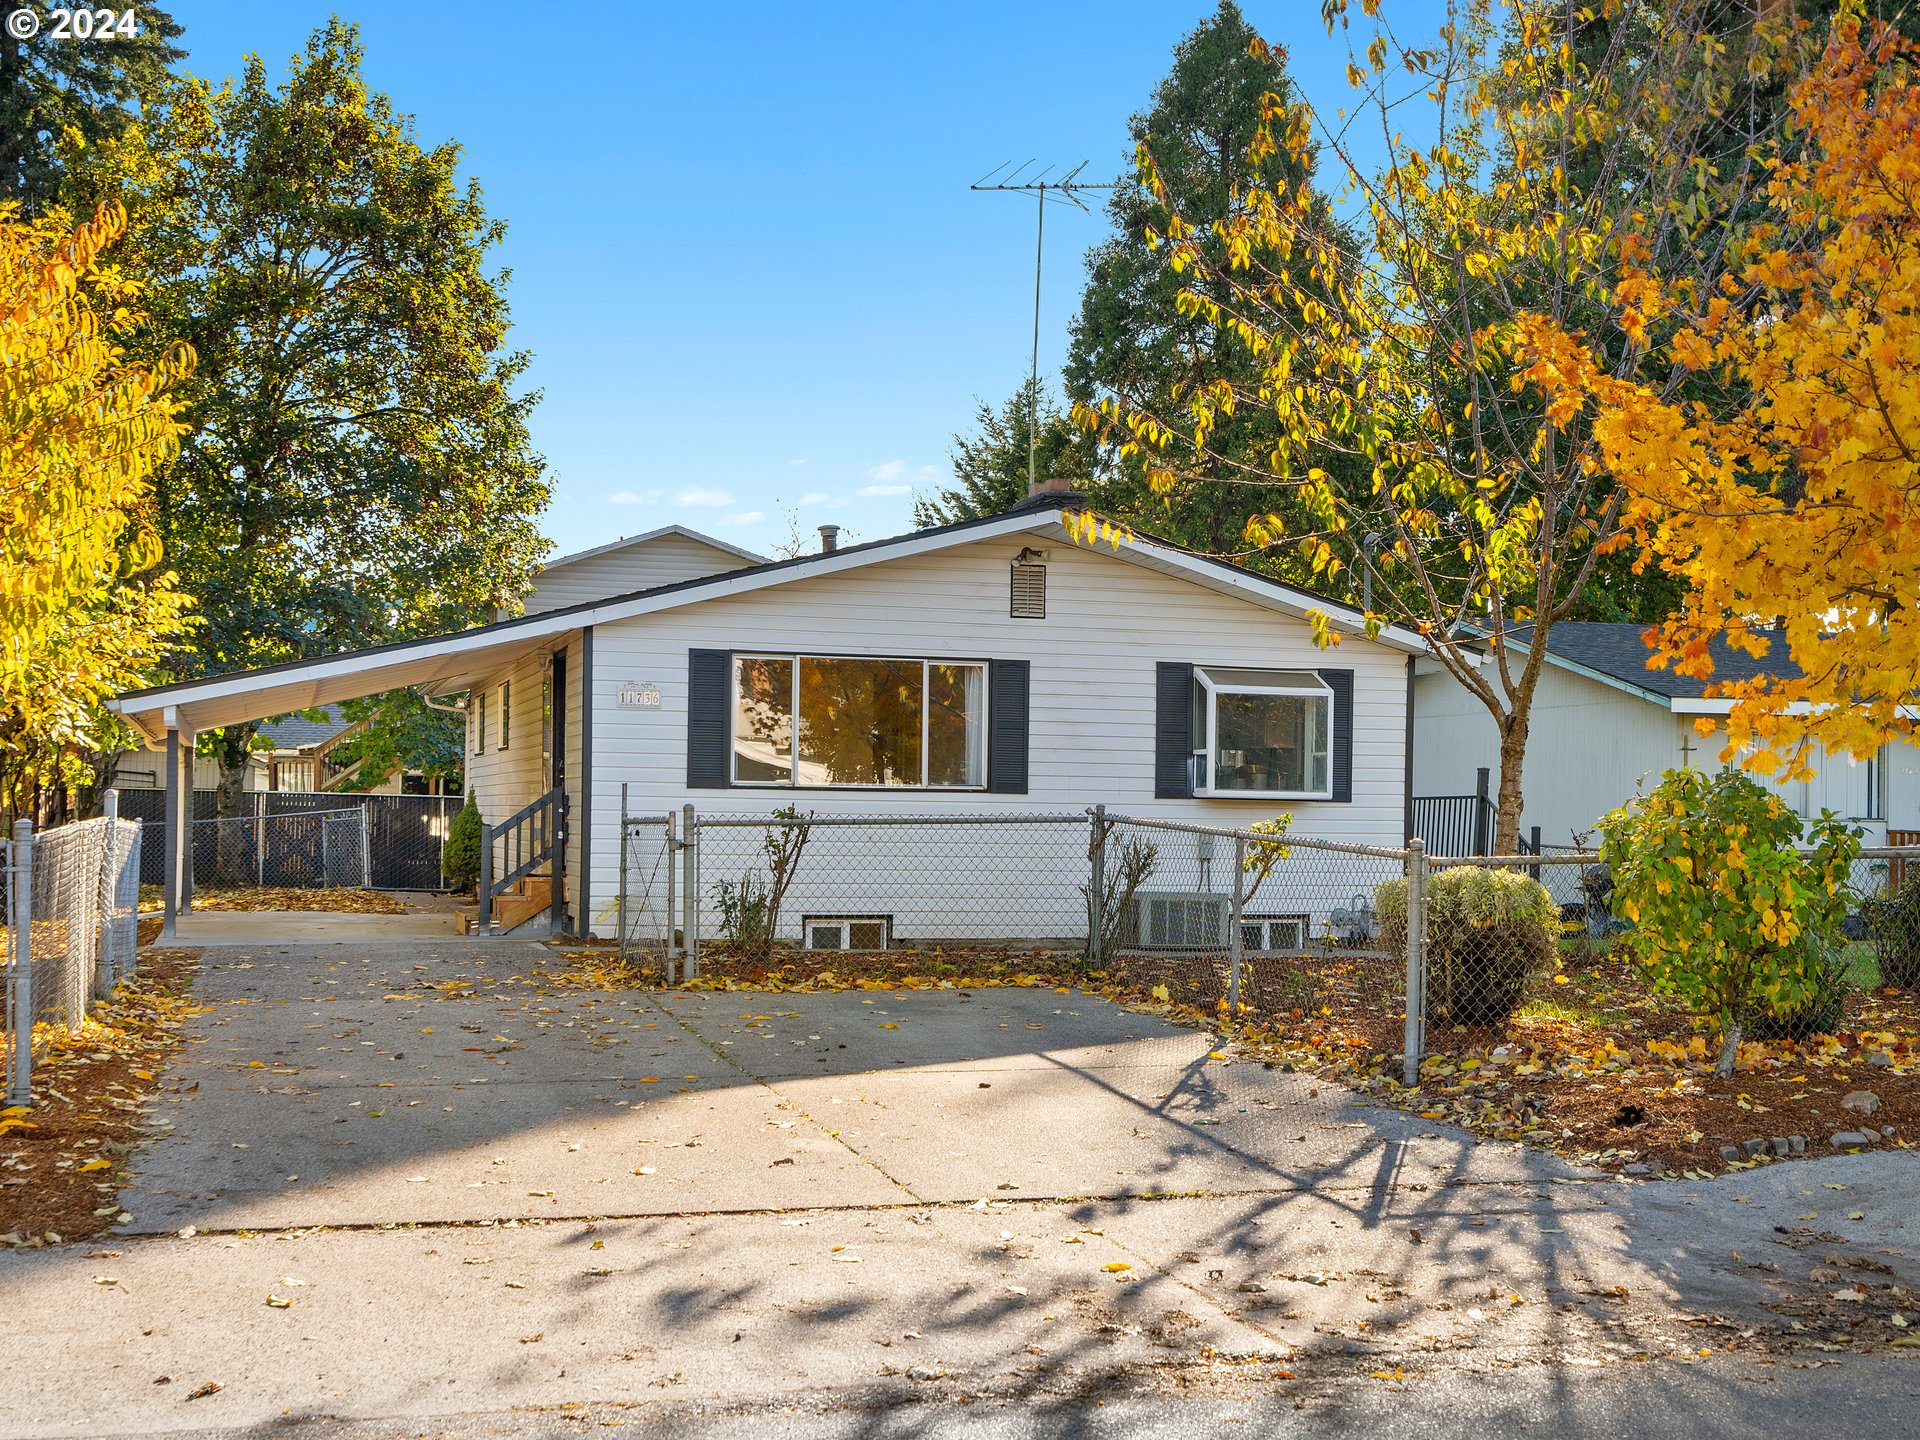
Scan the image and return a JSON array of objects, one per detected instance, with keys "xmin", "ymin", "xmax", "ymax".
[{"xmin": 1413, "ymin": 620, "xmax": 1920, "ymax": 845}]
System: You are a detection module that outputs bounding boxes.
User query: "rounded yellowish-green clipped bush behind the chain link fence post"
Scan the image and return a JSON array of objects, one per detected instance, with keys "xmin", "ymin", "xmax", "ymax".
[{"xmin": 1373, "ymin": 866, "xmax": 1559, "ymax": 1025}]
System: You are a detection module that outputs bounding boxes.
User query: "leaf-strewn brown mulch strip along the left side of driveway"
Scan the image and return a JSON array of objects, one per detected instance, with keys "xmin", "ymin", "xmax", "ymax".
[{"xmin": 0, "ymin": 950, "xmax": 200, "ymax": 1246}]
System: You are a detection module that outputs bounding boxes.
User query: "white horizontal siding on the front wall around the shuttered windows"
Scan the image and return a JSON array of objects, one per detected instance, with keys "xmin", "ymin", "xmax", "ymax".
[{"xmin": 576, "ymin": 538, "xmax": 1405, "ymax": 933}]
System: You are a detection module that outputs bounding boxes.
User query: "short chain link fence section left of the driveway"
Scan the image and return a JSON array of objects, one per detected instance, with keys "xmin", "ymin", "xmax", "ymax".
[{"xmin": 0, "ymin": 806, "xmax": 142, "ymax": 1104}]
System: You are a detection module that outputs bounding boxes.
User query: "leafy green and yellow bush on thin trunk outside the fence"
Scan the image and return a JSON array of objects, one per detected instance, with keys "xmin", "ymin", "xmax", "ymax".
[{"xmin": 1599, "ymin": 770, "xmax": 1860, "ymax": 1077}]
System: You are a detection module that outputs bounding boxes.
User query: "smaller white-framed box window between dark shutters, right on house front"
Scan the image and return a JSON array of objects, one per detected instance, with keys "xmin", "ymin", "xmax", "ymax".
[{"xmin": 1192, "ymin": 666, "xmax": 1332, "ymax": 799}]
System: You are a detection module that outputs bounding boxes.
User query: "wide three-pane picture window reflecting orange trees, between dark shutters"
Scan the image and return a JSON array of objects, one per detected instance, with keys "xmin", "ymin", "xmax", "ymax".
[{"xmin": 733, "ymin": 655, "xmax": 987, "ymax": 789}]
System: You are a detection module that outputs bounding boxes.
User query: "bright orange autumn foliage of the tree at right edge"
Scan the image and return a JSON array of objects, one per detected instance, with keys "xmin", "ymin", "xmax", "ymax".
[{"xmin": 1524, "ymin": 15, "xmax": 1920, "ymax": 778}]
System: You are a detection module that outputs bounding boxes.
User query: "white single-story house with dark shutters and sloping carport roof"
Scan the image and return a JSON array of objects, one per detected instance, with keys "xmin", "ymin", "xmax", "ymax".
[{"xmin": 115, "ymin": 486, "xmax": 1430, "ymax": 948}]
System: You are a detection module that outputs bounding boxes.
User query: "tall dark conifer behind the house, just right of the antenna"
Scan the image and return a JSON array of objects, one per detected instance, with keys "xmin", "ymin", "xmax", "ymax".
[{"xmin": 1066, "ymin": 0, "xmax": 1348, "ymax": 578}]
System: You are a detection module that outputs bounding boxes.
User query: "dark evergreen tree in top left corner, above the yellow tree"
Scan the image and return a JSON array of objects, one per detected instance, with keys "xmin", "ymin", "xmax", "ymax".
[{"xmin": 0, "ymin": 0, "xmax": 186, "ymax": 213}]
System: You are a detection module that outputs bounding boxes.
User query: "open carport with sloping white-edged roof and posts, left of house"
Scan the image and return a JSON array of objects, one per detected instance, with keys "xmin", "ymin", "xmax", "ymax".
[{"xmin": 109, "ymin": 612, "xmax": 593, "ymax": 943}]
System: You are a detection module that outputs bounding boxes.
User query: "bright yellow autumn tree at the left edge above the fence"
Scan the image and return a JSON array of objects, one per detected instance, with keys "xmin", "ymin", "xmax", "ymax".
[{"xmin": 0, "ymin": 207, "xmax": 192, "ymax": 816}]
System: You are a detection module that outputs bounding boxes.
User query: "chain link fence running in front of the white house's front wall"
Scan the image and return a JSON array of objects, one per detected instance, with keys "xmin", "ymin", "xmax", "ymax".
[{"xmin": 618, "ymin": 806, "xmax": 1920, "ymax": 1083}]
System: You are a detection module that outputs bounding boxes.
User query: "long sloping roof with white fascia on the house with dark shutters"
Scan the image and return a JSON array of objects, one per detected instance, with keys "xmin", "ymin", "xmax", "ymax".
[{"xmin": 109, "ymin": 497, "xmax": 1428, "ymax": 741}]
